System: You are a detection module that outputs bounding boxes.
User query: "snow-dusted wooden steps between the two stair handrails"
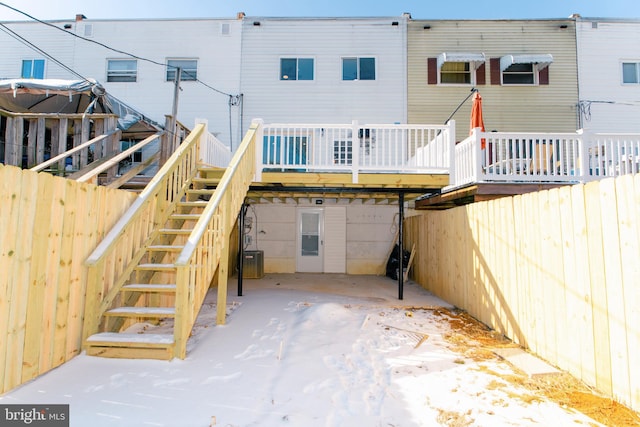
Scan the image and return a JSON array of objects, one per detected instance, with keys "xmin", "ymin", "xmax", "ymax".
[{"xmin": 85, "ymin": 167, "xmax": 229, "ymax": 360}]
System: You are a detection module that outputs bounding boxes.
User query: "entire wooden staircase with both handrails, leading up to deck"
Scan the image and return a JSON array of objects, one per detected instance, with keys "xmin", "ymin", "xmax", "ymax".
[{"xmin": 82, "ymin": 122, "xmax": 261, "ymax": 359}]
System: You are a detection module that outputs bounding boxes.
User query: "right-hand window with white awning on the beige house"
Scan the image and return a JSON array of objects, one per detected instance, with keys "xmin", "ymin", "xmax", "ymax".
[{"xmin": 492, "ymin": 54, "xmax": 553, "ymax": 86}]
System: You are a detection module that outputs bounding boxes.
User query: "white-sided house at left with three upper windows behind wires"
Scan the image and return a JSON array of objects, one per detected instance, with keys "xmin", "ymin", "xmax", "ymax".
[{"xmin": 0, "ymin": 16, "xmax": 242, "ymax": 146}]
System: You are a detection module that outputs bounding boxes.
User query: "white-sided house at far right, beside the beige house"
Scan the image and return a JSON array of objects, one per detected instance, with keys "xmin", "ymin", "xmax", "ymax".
[{"xmin": 576, "ymin": 18, "xmax": 640, "ymax": 132}]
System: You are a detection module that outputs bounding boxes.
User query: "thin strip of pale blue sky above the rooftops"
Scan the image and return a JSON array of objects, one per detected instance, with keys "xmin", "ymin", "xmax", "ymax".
[{"xmin": 0, "ymin": 0, "xmax": 640, "ymax": 21}]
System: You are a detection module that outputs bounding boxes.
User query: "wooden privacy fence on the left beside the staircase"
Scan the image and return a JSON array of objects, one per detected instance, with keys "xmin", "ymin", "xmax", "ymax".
[{"xmin": 0, "ymin": 165, "xmax": 136, "ymax": 393}]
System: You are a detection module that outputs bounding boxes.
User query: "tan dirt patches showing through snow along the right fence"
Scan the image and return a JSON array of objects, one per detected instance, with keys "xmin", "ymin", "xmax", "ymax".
[{"xmin": 420, "ymin": 308, "xmax": 640, "ymax": 427}]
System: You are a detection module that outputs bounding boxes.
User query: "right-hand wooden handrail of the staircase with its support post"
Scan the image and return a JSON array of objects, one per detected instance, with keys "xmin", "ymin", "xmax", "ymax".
[{"xmin": 174, "ymin": 121, "xmax": 262, "ymax": 358}]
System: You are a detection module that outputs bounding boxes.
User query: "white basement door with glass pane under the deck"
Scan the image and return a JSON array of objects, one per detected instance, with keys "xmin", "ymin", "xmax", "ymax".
[{"xmin": 296, "ymin": 208, "xmax": 324, "ymax": 273}]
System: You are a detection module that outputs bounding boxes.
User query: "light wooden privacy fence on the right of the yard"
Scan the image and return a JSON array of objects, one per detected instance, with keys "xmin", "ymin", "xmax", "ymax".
[{"xmin": 404, "ymin": 174, "xmax": 640, "ymax": 410}]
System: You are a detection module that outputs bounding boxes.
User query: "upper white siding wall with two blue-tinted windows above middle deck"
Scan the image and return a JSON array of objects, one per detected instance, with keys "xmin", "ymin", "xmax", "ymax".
[{"xmin": 242, "ymin": 16, "xmax": 407, "ymax": 127}]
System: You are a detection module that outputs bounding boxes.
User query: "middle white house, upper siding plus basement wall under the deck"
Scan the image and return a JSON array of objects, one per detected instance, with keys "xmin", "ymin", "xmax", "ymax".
[{"xmin": 241, "ymin": 16, "xmax": 408, "ymax": 274}]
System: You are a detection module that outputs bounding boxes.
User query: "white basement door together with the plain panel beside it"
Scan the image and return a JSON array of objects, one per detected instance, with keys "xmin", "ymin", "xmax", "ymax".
[{"xmin": 296, "ymin": 206, "xmax": 346, "ymax": 273}]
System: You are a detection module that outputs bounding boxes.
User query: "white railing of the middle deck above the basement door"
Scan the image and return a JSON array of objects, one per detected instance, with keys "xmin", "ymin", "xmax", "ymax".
[{"xmin": 256, "ymin": 121, "xmax": 455, "ymax": 182}]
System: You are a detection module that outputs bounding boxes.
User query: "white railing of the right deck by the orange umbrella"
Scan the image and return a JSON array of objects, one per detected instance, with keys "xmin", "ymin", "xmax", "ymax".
[{"xmin": 450, "ymin": 129, "xmax": 640, "ymax": 187}]
